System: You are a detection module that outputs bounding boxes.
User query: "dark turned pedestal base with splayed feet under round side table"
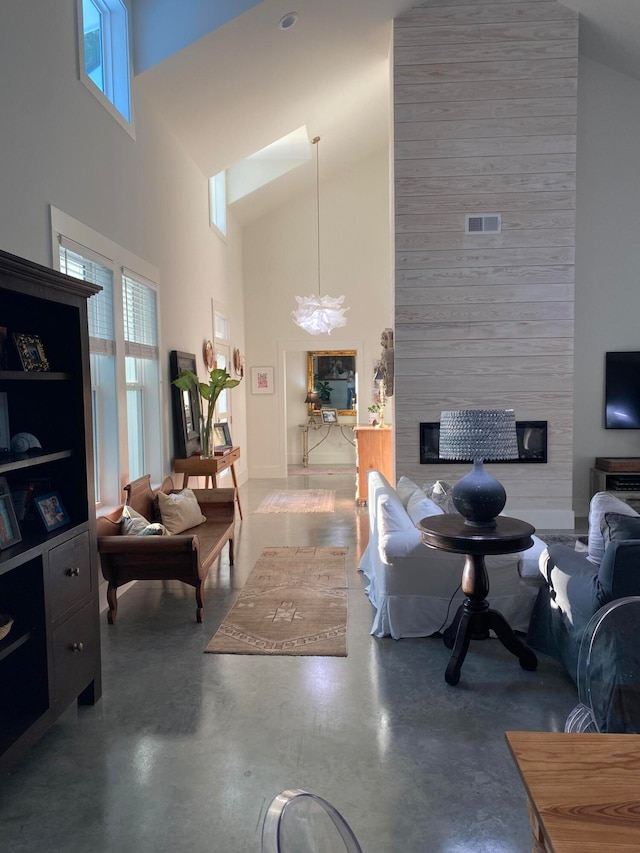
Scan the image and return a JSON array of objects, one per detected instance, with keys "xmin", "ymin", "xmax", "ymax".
[{"xmin": 443, "ymin": 554, "xmax": 538, "ymax": 685}]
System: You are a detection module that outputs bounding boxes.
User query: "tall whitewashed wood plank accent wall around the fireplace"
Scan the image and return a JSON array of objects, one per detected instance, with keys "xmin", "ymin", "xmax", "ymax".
[{"xmin": 394, "ymin": 0, "xmax": 578, "ymax": 526}]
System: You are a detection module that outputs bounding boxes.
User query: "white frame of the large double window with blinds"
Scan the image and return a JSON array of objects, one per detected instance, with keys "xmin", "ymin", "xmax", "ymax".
[{"xmin": 51, "ymin": 206, "xmax": 166, "ymax": 509}]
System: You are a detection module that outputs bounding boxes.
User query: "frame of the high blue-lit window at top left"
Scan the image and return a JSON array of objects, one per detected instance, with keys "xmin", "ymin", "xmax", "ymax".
[{"xmin": 76, "ymin": 0, "xmax": 135, "ymax": 139}]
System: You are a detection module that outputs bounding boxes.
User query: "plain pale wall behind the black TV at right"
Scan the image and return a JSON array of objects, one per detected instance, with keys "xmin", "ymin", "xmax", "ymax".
[{"xmin": 574, "ymin": 57, "xmax": 640, "ymax": 516}]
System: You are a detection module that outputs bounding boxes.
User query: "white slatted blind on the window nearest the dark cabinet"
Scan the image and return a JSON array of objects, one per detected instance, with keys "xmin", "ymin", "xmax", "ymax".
[{"xmin": 59, "ymin": 237, "xmax": 115, "ymax": 355}]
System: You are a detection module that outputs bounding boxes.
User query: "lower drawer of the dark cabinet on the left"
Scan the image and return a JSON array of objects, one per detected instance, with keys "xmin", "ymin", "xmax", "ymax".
[{"xmin": 53, "ymin": 602, "xmax": 100, "ymax": 704}]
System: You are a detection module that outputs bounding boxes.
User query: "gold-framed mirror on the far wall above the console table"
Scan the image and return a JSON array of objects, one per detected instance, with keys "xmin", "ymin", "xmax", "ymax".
[{"xmin": 307, "ymin": 349, "xmax": 358, "ymax": 415}]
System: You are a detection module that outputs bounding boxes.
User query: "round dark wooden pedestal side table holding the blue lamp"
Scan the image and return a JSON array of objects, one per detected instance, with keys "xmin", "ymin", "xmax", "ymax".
[{"xmin": 418, "ymin": 515, "xmax": 538, "ymax": 685}]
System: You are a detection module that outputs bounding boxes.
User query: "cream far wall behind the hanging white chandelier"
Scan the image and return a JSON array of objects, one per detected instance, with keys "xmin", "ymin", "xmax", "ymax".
[{"xmin": 243, "ymin": 150, "xmax": 391, "ymax": 477}]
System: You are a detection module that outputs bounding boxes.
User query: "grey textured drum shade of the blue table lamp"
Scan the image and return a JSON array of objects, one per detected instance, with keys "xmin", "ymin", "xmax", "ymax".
[{"xmin": 439, "ymin": 409, "xmax": 518, "ymax": 461}]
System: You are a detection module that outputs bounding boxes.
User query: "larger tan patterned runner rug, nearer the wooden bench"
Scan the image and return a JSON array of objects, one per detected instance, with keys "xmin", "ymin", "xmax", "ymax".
[{"xmin": 205, "ymin": 547, "xmax": 347, "ymax": 657}]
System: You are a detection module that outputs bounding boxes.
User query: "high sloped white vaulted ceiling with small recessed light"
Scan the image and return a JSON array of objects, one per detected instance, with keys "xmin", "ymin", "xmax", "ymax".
[{"xmin": 132, "ymin": 0, "xmax": 640, "ymax": 222}]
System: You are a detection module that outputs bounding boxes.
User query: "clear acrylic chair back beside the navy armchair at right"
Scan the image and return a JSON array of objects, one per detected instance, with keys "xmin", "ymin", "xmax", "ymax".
[{"xmin": 564, "ymin": 595, "xmax": 640, "ymax": 734}]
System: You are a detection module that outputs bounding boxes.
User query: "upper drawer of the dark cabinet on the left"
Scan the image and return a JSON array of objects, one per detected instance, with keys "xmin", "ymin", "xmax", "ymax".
[{"xmin": 49, "ymin": 532, "xmax": 94, "ymax": 622}]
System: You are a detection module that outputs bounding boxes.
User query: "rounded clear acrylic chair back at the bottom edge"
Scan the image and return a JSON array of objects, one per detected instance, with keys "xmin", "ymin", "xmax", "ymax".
[{"xmin": 262, "ymin": 790, "xmax": 362, "ymax": 853}]
